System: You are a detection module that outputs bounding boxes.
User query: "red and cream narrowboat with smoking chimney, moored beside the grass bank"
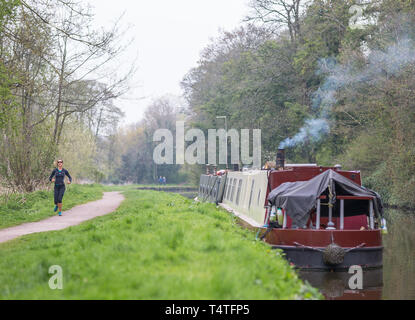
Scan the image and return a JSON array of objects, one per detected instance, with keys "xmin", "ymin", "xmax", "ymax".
[{"xmin": 198, "ymin": 149, "xmax": 386, "ymax": 271}]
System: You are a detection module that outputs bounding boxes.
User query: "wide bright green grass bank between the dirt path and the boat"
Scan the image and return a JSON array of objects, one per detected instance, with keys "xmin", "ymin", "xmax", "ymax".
[{"xmin": 0, "ymin": 190, "xmax": 321, "ymax": 299}]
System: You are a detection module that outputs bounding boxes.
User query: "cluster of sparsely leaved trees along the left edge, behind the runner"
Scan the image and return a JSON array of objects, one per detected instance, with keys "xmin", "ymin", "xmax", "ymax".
[{"xmin": 0, "ymin": 0, "xmax": 133, "ymax": 192}]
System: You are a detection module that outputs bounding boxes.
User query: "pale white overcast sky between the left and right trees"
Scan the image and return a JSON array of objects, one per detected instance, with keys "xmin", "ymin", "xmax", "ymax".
[{"xmin": 86, "ymin": 0, "xmax": 249, "ymax": 124}]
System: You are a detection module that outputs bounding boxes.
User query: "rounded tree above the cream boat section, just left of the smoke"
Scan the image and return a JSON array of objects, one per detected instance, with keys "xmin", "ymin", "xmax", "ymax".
[{"xmin": 182, "ymin": 25, "xmax": 309, "ymax": 165}]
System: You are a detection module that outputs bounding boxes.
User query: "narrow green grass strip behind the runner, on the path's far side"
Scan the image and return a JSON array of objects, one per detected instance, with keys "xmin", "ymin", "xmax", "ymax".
[{"xmin": 0, "ymin": 184, "xmax": 104, "ymax": 229}]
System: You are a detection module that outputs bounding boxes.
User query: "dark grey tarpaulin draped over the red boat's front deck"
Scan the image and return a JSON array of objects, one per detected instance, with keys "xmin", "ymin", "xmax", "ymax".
[{"xmin": 268, "ymin": 170, "xmax": 383, "ymax": 227}]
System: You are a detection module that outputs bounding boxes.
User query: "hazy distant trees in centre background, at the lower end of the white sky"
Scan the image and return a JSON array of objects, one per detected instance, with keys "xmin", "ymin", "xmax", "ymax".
[{"xmin": 99, "ymin": 96, "xmax": 186, "ymax": 184}]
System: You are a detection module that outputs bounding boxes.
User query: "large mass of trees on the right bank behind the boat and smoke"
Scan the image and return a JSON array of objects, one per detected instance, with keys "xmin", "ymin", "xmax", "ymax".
[{"xmin": 182, "ymin": 0, "xmax": 415, "ymax": 206}]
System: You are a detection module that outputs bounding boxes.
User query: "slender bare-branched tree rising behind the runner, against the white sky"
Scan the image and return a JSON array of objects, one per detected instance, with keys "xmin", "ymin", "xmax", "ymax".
[{"xmin": 22, "ymin": 0, "xmax": 134, "ymax": 144}]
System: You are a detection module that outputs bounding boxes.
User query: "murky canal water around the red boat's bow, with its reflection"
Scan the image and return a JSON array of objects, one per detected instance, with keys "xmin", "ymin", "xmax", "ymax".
[{"xmin": 299, "ymin": 209, "xmax": 415, "ymax": 300}]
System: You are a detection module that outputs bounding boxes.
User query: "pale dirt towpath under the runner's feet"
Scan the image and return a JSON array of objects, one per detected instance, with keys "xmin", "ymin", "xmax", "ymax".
[{"xmin": 0, "ymin": 192, "xmax": 124, "ymax": 243}]
